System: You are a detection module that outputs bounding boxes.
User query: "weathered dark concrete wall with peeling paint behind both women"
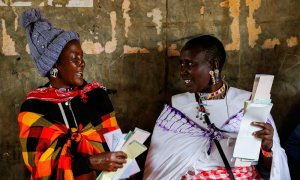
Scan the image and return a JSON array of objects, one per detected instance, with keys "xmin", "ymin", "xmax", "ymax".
[{"xmin": 0, "ymin": 0, "xmax": 300, "ymax": 179}]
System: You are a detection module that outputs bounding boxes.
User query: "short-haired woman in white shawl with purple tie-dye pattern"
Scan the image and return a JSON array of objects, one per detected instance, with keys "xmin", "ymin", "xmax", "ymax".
[{"xmin": 144, "ymin": 35, "xmax": 290, "ymax": 180}]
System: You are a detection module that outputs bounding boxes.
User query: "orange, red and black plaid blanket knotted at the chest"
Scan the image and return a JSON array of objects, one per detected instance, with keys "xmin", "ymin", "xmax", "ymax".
[{"xmin": 18, "ymin": 112, "xmax": 118, "ymax": 179}]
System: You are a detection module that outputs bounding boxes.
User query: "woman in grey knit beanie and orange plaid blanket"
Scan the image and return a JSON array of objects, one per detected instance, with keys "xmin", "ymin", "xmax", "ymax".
[{"xmin": 18, "ymin": 9, "xmax": 127, "ymax": 179}]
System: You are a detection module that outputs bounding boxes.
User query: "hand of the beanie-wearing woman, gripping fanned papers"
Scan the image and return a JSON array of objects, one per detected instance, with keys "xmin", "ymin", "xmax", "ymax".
[{"xmin": 90, "ymin": 151, "xmax": 127, "ymax": 171}]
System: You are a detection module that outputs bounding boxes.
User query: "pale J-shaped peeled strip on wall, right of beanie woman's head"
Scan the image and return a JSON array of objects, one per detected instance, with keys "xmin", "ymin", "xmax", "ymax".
[{"xmin": 105, "ymin": 11, "xmax": 117, "ymax": 53}]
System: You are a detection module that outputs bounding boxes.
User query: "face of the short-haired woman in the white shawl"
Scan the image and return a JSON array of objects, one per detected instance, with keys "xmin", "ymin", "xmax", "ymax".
[{"xmin": 180, "ymin": 49, "xmax": 211, "ymax": 93}]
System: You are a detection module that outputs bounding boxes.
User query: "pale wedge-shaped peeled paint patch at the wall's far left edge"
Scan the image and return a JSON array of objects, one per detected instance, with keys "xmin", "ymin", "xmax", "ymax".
[{"xmin": 1, "ymin": 19, "xmax": 18, "ymax": 56}]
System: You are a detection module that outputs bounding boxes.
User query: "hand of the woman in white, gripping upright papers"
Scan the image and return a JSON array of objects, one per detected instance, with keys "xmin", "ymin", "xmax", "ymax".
[{"xmin": 251, "ymin": 122, "xmax": 274, "ymax": 151}]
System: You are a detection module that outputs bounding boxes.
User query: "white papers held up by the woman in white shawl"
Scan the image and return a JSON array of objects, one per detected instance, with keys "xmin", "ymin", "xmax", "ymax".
[{"xmin": 233, "ymin": 74, "xmax": 274, "ymax": 166}]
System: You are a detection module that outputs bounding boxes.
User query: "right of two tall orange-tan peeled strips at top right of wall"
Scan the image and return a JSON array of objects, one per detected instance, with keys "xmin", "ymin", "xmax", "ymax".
[{"xmin": 246, "ymin": 0, "xmax": 261, "ymax": 48}]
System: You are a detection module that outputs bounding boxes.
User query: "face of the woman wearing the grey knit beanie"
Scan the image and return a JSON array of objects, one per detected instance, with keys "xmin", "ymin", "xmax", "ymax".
[{"xmin": 56, "ymin": 40, "xmax": 85, "ymax": 88}]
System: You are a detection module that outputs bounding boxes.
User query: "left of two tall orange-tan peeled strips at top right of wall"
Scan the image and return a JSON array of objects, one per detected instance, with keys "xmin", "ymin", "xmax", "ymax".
[{"xmin": 220, "ymin": 0, "xmax": 241, "ymax": 51}]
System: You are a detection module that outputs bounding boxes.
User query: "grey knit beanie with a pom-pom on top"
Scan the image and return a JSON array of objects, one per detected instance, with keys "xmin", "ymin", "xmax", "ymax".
[{"xmin": 21, "ymin": 9, "xmax": 79, "ymax": 76}]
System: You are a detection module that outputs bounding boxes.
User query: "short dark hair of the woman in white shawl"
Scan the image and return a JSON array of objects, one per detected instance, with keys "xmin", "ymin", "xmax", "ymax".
[{"xmin": 181, "ymin": 35, "xmax": 226, "ymax": 71}]
